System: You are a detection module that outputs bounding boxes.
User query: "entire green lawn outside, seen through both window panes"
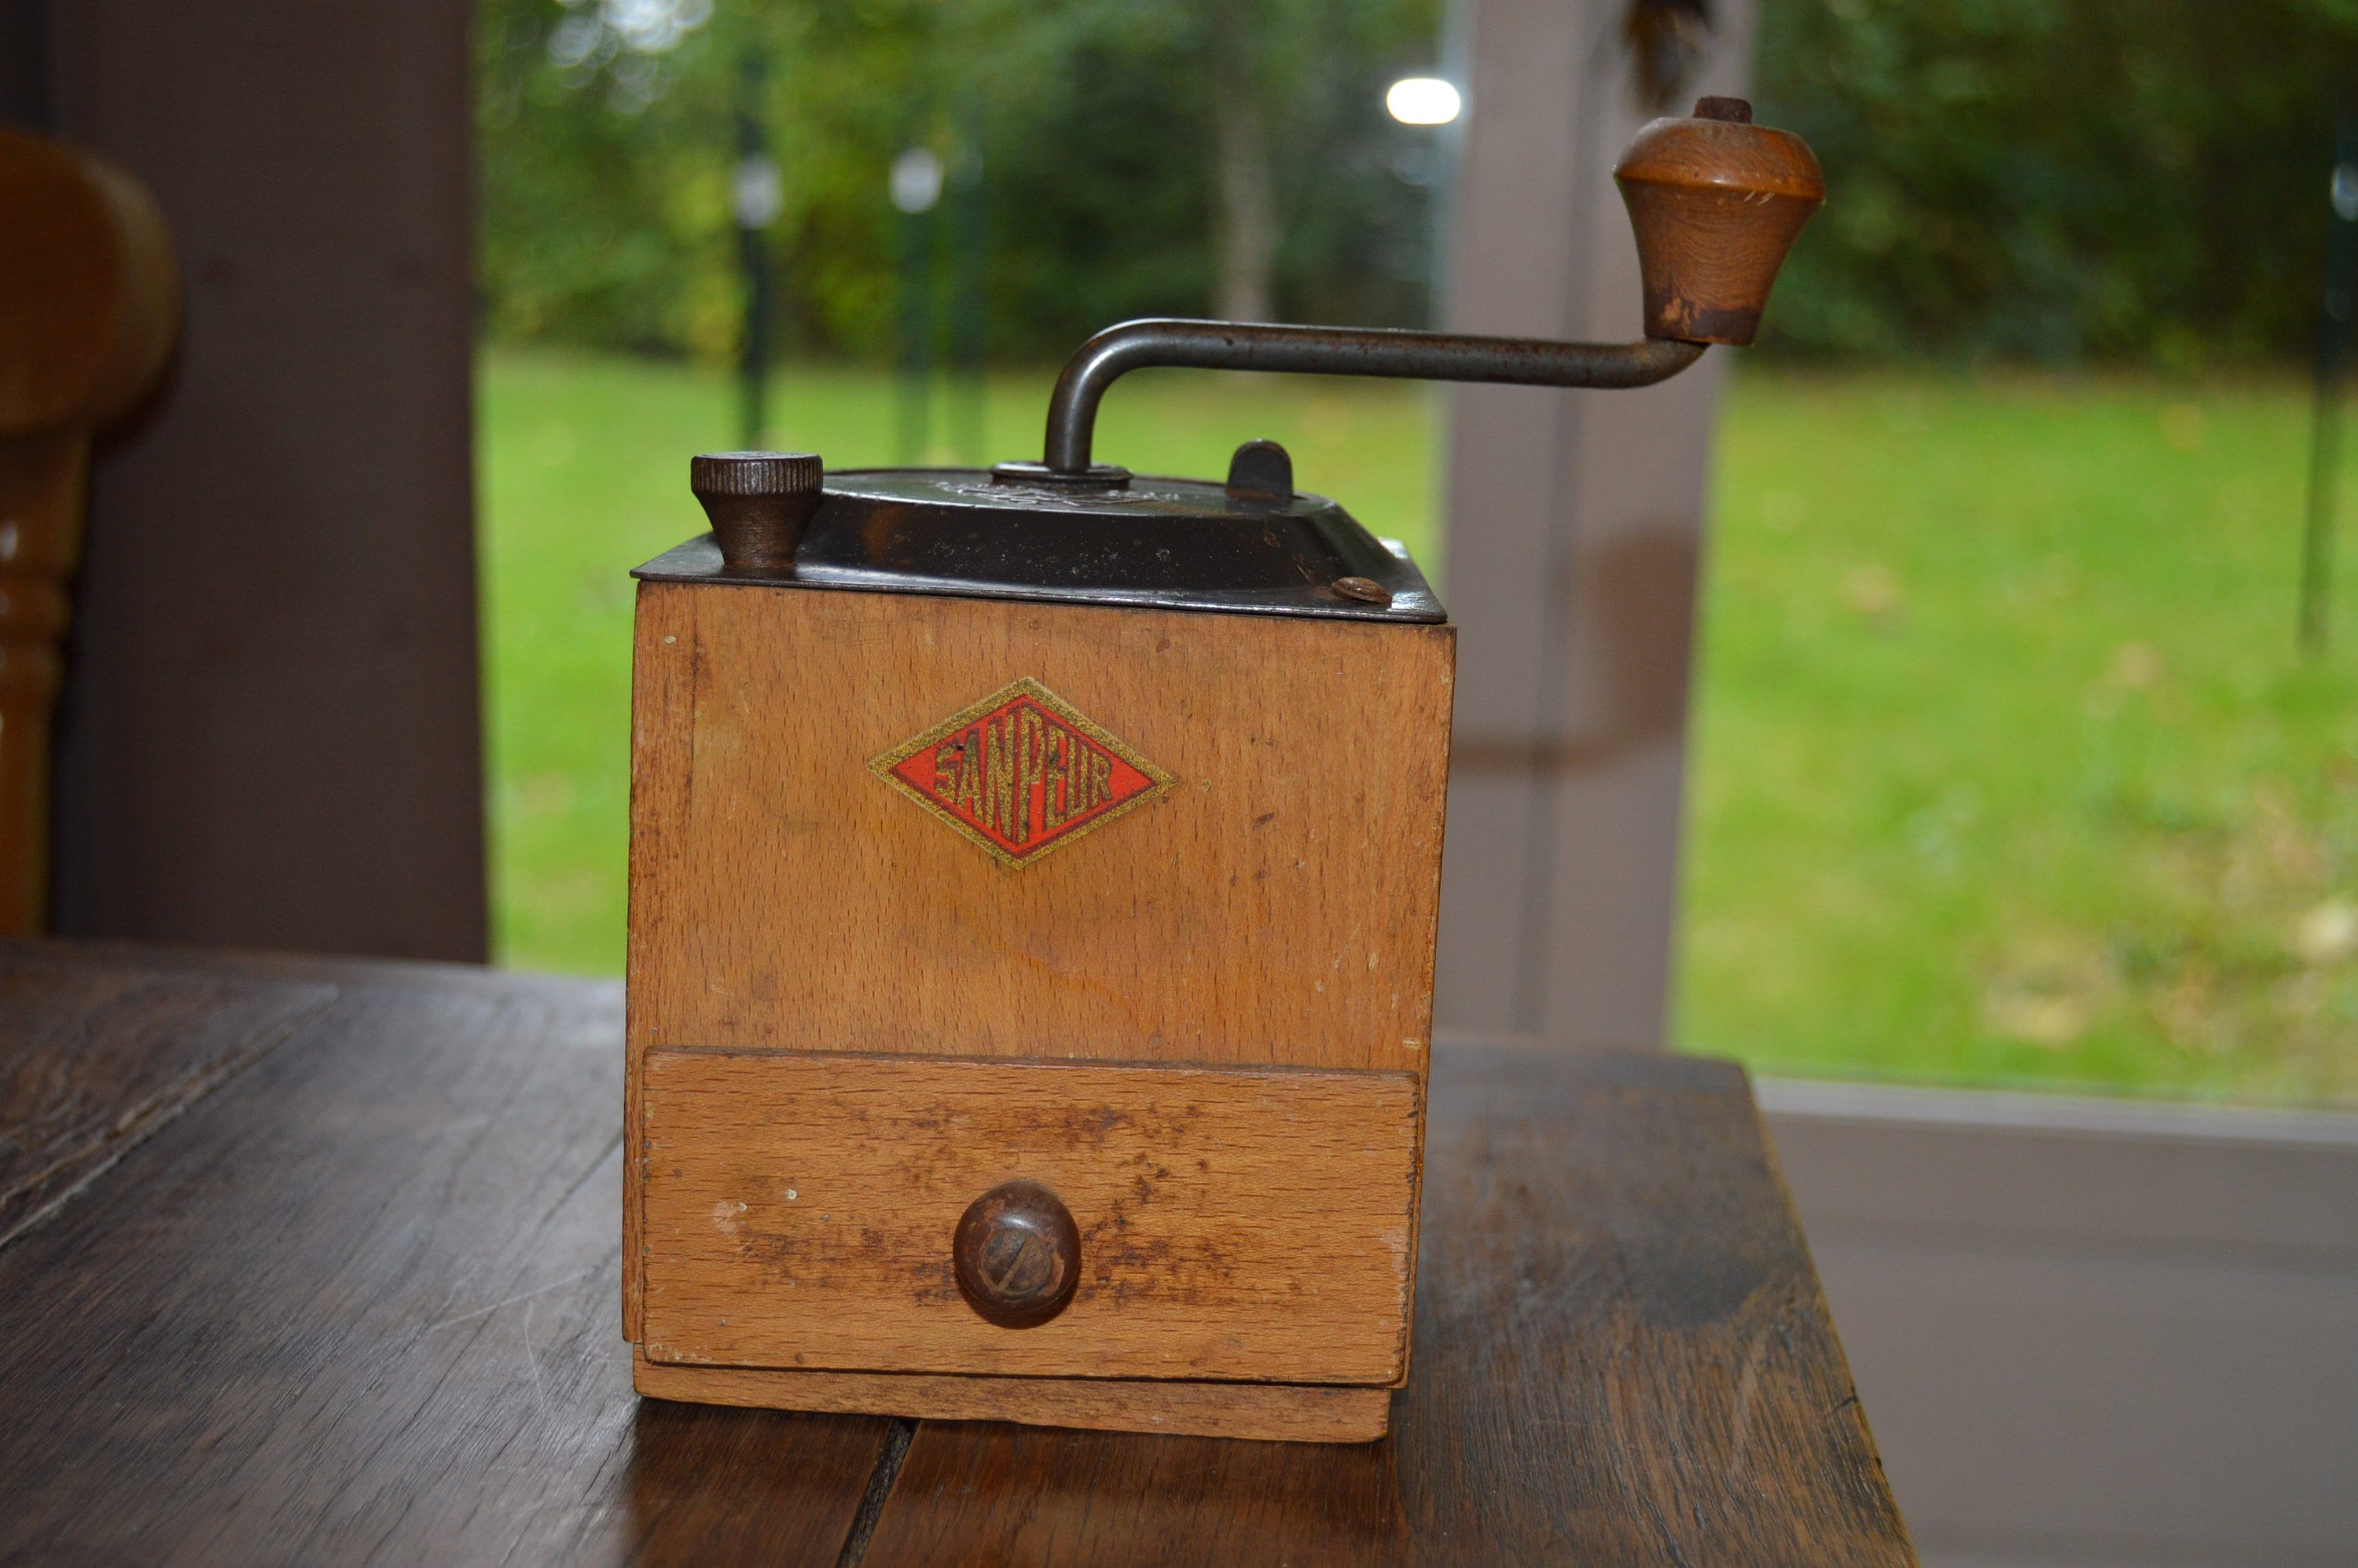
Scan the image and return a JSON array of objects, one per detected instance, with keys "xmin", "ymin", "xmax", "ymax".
[{"xmin": 481, "ymin": 351, "xmax": 2358, "ymax": 1099}]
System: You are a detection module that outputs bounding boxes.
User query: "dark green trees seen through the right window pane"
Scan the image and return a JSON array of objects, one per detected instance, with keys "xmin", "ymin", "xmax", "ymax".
[{"xmin": 1759, "ymin": 0, "xmax": 2358, "ymax": 365}]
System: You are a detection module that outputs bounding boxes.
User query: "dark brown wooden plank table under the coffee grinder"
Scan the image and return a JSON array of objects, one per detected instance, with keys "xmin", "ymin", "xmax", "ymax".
[{"xmin": 0, "ymin": 946, "xmax": 1915, "ymax": 1568}]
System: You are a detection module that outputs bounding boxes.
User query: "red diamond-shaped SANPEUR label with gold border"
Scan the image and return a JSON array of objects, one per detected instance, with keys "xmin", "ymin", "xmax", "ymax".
[{"xmin": 868, "ymin": 674, "xmax": 1174, "ymax": 868}]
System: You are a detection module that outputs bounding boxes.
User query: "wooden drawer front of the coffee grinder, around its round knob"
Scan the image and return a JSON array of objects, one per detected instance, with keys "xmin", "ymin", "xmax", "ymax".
[{"xmin": 641, "ymin": 1049, "xmax": 1422, "ymax": 1384}]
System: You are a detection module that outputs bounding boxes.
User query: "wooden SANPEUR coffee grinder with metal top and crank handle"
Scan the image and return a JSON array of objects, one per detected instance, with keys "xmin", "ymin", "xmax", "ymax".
[{"xmin": 623, "ymin": 99, "xmax": 1820, "ymax": 1441}]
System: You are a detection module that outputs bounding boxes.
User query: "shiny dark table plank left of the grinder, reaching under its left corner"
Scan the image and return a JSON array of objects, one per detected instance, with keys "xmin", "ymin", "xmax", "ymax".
[{"xmin": 0, "ymin": 948, "xmax": 896, "ymax": 1566}]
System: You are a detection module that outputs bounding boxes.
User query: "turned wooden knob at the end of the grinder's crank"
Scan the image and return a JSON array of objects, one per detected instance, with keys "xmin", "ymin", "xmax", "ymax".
[{"xmin": 1613, "ymin": 99, "xmax": 1825, "ymax": 344}]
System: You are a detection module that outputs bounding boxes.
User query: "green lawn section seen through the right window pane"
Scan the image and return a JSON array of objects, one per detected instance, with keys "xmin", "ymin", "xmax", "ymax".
[{"xmin": 1677, "ymin": 377, "xmax": 2358, "ymax": 1101}]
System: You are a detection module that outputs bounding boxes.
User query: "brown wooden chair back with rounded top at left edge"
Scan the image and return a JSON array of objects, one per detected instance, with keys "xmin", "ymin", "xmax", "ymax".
[{"xmin": 0, "ymin": 130, "xmax": 179, "ymax": 936}]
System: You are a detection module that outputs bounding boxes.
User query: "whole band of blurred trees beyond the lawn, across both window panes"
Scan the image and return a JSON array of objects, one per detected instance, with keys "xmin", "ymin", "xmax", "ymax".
[{"xmin": 479, "ymin": 0, "xmax": 2358, "ymax": 365}]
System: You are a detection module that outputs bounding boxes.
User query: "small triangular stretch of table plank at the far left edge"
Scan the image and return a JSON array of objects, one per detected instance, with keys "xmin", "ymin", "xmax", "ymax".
[{"xmin": 0, "ymin": 943, "xmax": 335, "ymax": 1245}]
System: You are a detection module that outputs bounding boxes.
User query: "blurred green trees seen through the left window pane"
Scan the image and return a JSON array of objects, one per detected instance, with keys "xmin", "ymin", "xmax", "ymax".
[{"xmin": 479, "ymin": 0, "xmax": 1438, "ymax": 358}]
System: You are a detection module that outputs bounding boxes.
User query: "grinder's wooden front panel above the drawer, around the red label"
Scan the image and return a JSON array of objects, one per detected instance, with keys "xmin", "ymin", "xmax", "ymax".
[{"xmin": 630, "ymin": 582, "xmax": 1453, "ymax": 1070}]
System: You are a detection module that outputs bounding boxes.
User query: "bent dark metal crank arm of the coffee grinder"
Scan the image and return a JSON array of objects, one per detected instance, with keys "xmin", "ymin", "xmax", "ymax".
[{"xmin": 1047, "ymin": 321, "xmax": 1705, "ymax": 476}]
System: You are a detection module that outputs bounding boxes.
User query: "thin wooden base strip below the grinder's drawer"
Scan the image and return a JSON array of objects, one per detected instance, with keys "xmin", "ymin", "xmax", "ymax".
[{"xmin": 634, "ymin": 1353, "xmax": 1391, "ymax": 1443}]
